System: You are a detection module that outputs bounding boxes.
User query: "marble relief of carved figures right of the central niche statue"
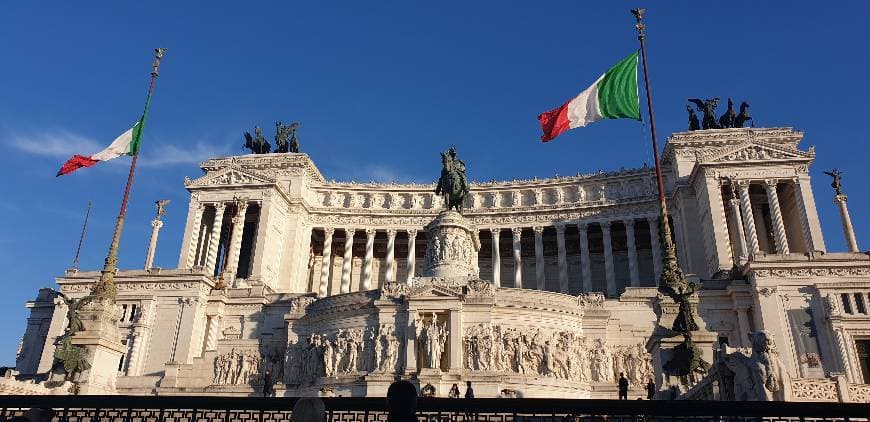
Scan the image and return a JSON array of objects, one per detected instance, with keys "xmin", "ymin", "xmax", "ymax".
[{"xmin": 463, "ymin": 324, "xmax": 653, "ymax": 385}]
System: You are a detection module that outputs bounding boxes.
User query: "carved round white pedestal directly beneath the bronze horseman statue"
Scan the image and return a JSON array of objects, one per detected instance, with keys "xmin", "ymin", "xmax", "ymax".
[{"xmin": 423, "ymin": 211, "xmax": 480, "ymax": 279}]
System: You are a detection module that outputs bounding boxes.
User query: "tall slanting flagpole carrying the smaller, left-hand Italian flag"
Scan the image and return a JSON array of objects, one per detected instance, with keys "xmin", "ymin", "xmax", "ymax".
[{"xmin": 91, "ymin": 48, "xmax": 166, "ymax": 302}]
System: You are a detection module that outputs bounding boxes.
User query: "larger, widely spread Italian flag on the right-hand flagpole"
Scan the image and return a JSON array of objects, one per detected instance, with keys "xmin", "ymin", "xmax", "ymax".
[{"xmin": 538, "ymin": 51, "xmax": 640, "ymax": 142}]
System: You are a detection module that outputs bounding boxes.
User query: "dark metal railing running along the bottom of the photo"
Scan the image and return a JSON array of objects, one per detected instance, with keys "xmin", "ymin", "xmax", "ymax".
[{"xmin": 0, "ymin": 396, "xmax": 870, "ymax": 422}]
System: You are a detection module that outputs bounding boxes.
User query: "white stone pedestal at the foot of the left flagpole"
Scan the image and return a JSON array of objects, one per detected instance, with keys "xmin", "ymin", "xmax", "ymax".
[{"xmin": 71, "ymin": 301, "xmax": 127, "ymax": 395}]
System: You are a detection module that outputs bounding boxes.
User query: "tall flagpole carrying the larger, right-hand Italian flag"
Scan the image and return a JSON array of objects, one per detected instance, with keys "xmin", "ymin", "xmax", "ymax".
[{"xmin": 631, "ymin": 9, "xmax": 683, "ymax": 286}]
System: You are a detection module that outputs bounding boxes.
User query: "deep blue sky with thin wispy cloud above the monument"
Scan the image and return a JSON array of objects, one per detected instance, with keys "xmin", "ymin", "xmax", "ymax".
[{"xmin": 0, "ymin": 0, "xmax": 870, "ymax": 365}]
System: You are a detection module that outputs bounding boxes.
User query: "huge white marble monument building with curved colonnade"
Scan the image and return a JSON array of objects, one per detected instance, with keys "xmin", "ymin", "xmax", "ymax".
[{"xmin": 16, "ymin": 128, "xmax": 870, "ymax": 400}]
